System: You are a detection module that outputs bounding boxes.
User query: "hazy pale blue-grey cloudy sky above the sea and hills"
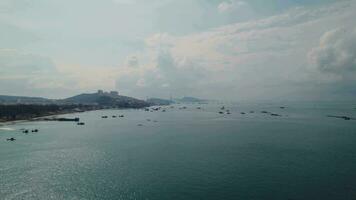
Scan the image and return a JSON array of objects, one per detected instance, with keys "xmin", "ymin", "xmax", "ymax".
[{"xmin": 0, "ymin": 0, "xmax": 356, "ymax": 101}]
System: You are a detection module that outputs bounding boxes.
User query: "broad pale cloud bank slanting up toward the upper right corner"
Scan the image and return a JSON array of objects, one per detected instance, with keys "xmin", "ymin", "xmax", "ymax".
[{"xmin": 113, "ymin": 0, "xmax": 355, "ymax": 99}]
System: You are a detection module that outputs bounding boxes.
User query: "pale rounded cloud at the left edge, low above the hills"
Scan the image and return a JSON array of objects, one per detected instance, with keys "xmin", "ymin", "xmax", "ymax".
[{"xmin": 0, "ymin": 49, "xmax": 75, "ymax": 97}]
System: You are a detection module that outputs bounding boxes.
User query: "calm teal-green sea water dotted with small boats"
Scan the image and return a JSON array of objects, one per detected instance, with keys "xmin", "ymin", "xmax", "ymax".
[{"xmin": 0, "ymin": 103, "xmax": 356, "ymax": 200}]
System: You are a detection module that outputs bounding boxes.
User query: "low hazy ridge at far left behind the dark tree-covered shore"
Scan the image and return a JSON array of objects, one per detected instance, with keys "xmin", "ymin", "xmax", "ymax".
[{"xmin": 0, "ymin": 95, "xmax": 55, "ymax": 104}]
